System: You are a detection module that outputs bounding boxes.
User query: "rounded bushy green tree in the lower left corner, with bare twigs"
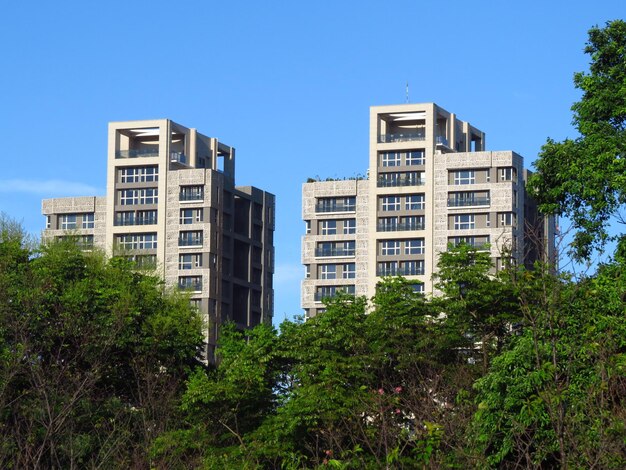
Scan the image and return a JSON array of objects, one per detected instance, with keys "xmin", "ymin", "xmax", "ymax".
[{"xmin": 0, "ymin": 219, "xmax": 201, "ymax": 468}]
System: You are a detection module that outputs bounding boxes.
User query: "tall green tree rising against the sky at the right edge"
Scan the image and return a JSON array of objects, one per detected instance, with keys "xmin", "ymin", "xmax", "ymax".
[{"xmin": 530, "ymin": 20, "xmax": 626, "ymax": 257}]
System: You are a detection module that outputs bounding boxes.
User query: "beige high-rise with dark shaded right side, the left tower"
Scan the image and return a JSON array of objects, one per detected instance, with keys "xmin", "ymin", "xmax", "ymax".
[{"xmin": 42, "ymin": 119, "xmax": 275, "ymax": 358}]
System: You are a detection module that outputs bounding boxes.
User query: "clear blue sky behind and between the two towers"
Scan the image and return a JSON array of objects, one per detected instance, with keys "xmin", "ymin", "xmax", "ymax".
[{"xmin": 0, "ymin": 0, "xmax": 626, "ymax": 322}]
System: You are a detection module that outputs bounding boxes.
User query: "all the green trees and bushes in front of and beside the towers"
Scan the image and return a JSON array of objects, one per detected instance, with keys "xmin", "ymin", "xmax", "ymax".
[{"xmin": 0, "ymin": 21, "xmax": 626, "ymax": 469}]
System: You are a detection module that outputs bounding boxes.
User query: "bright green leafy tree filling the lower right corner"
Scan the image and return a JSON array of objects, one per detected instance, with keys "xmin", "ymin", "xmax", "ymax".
[{"xmin": 469, "ymin": 264, "xmax": 626, "ymax": 468}]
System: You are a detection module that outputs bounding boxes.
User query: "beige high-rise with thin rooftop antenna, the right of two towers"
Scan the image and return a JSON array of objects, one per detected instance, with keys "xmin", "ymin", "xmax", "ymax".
[{"xmin": 302, "ymin": 103, "xmax": 555, "ymax": 316}]
